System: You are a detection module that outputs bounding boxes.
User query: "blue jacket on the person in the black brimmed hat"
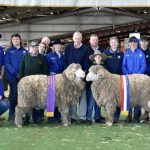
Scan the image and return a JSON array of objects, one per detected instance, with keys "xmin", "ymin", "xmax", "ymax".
[{"xmin": 46, "ymin": 52, "xmax": 65, "ymax": 74}]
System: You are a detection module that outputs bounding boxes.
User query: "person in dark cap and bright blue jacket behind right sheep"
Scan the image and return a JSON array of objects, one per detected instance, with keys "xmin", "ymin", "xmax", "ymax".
[{"xmin": 122, "ymin": 36, "xmax": 146, "ymax": 122}]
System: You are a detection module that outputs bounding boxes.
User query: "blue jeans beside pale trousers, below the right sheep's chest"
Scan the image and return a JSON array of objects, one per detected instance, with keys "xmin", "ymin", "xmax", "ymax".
[{"xmin": 86, "ymin": 85, "xmax": 101, "ymax": 121}]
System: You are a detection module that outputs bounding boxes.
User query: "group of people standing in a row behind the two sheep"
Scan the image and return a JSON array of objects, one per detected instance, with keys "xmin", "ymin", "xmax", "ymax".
[{"xmin": 0, "ymin": 32, "xmax": 150, "ymax": 125}]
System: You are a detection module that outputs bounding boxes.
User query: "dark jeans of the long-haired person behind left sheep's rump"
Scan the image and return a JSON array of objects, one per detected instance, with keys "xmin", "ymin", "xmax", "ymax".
[{"xmin": 8, "ymin": 80, "xmax": 19, "ymax": 117}]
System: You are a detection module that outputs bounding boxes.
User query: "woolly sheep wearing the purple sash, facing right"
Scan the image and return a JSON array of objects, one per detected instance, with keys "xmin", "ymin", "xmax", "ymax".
[{"xmin": 15, "ymin": 64, "xmax": 85, "ymax": 127}]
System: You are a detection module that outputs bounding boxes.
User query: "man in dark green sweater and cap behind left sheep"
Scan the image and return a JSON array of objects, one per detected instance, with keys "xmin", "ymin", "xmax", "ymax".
[{"xmin": 19, "ymin": 41, "xmax": 48, "ymax": 124}]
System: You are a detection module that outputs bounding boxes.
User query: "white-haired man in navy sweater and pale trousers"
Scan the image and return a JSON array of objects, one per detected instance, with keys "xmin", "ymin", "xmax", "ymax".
[{"xmin": 64, "ymin": 32, "xmax": 89, "ymax": 122}]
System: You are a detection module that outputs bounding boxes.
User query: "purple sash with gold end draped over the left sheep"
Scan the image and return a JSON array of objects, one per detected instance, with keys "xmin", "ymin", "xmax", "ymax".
[{"xmin": 46, "ymin": 75, "xmax": 56, "ymax": 117}]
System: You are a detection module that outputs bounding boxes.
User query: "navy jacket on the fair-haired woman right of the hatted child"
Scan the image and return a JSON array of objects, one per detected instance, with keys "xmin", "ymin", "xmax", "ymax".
[{"xmin": 104, "ymin": 49, "xmax": 123, "ymax": 75}]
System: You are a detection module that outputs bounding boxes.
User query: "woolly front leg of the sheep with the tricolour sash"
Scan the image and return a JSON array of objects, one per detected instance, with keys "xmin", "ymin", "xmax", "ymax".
[{"xmin": 105, "ymin": 102, "xmax": 116, "ymax": 126}]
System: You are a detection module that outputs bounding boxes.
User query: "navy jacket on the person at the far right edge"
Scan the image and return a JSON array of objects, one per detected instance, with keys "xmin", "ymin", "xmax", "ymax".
[{"xmin": 141, "ymin": 49, "xmax": 150, "ymax": 76}]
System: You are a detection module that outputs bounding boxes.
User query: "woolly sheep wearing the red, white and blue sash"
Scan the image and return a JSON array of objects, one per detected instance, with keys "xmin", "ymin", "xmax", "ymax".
[{"xmin": 86, "ymin": 65, "xmax": 150, "ymax": 126}]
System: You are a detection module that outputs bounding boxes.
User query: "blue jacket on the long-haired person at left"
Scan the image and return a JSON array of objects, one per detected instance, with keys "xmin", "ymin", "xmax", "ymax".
[{"xmin": 5, "ymin": 47, "xmax": 27, "ymax": 80}]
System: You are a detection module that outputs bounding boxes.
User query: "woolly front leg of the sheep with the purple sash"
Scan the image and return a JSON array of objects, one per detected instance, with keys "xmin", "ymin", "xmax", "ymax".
[{"xmin": 60, "ymin": 105, "xmax": 69, "ymax": 127}]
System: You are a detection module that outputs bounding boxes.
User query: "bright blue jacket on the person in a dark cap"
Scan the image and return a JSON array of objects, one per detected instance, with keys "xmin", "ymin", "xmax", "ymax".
[{"xmin": 122, "ymin": 49, "xmax": 147, "ymax": 75}]
